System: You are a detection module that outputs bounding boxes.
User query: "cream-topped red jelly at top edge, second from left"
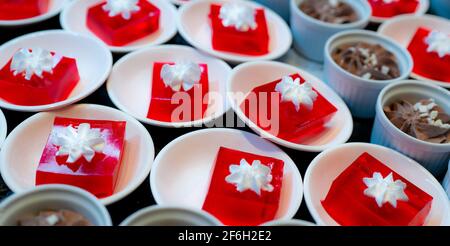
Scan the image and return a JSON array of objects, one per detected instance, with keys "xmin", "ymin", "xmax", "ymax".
[{"xmin": 87, "ymin": 0, "xmax": 161, "ymax": 46}]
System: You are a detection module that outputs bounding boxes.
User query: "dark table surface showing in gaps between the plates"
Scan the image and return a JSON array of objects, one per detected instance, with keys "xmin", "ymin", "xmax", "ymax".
[{"xmin": 0, "ymin": 13, "xmax": 442, "ymax": 224}]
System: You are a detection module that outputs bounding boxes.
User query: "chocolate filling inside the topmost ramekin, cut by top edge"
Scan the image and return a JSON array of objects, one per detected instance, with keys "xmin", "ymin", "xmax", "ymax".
[{"xmin": 299, "ymin": 0, "xmax": 358, "ymax": 24}]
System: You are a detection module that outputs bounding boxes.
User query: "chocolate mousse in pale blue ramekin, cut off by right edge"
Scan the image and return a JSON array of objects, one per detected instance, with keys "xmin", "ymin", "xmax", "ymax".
[{"xmin": 370, "ymin": 80, "xmax": 450, "ymax": 178}]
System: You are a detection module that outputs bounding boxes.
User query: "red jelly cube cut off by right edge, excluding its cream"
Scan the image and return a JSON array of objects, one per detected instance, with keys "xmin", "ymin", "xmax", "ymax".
[{"xmin": 408, "ymin": 27, "xmax": 450, "ymax": 82}]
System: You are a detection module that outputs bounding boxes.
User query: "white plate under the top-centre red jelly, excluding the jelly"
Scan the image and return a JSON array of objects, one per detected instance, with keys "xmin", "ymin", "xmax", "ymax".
[{"xmin": 178, "ymin": 0, "xmax": 292, "ymax": 63}]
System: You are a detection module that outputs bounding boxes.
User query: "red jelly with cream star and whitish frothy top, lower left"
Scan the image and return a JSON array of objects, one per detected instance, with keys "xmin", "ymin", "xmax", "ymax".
[{"xmin": 36, "ymin": 117, "xmax": 126, "ymax": 198}]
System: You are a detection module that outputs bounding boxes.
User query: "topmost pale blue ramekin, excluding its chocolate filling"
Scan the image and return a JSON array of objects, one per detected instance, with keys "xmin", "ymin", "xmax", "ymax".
[{"xmin": 290, "ymin": 0, "xmax": 371, "ymax": 63}]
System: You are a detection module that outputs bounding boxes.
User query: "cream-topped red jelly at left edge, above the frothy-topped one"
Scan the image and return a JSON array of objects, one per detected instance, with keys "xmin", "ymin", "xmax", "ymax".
[{"xmin": 0, "ymin": 48, "xmax": 80, "ymax": 106}]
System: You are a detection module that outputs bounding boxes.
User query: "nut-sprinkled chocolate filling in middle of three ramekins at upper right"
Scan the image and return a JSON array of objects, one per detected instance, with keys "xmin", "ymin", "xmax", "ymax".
[{"xmin": 331, "ymin": 42, "xmax": 400, "ymax": 80}]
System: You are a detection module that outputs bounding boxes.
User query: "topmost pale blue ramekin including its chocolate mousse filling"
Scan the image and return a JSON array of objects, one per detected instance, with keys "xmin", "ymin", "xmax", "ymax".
[{"xmin": 290, "ymin": 0, "xmax": 372, "ymax": 62}]
